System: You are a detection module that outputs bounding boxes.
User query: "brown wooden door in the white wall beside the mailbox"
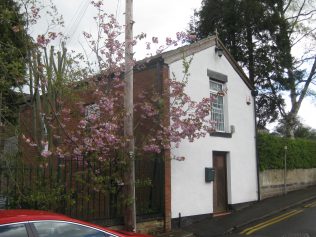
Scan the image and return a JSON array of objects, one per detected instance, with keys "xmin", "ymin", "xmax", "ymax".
[{"xmin": 213, "ymin": 152, "xmax": 228, "ymax": 213}]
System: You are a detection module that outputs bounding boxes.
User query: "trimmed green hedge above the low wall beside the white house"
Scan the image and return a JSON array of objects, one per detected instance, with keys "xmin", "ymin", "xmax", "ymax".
[{"xmin": 257, "ymin": 134, "xmax": 316, "ymax": 171}]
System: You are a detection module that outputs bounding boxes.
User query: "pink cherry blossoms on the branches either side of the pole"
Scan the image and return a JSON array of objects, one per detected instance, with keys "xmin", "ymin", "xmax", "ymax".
[{"xmin": 23, "ymin": 1, "xmax": 214, "ymax": 176}]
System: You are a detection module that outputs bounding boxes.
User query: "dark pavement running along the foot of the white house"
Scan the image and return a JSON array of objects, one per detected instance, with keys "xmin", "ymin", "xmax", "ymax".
[{"xmin": 158, "ymin": 186, "xmax": 316, "ymax": 237}]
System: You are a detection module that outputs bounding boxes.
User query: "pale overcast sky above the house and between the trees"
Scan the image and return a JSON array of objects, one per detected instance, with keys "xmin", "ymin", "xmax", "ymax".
[{"xmin": 34, "ymin": 0, "xmax": 316, "ymax": 129}]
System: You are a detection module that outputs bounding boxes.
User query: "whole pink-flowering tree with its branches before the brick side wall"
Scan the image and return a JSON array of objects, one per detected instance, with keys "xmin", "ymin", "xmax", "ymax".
[{"xmin": 18, "ymin": 1, "xmax": 213, "ymax": 231}]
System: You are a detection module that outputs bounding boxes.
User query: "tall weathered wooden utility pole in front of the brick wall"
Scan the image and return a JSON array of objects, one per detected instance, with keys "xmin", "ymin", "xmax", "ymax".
[{"xmin": 124, "ymin": 0, "xmax": 136, "ymax": 232}]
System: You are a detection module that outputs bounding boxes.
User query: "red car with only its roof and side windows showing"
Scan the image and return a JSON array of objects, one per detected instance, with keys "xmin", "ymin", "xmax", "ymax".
[{"xmin": 0, "ymin": 210, "xmax": 150, "ymax": 237}]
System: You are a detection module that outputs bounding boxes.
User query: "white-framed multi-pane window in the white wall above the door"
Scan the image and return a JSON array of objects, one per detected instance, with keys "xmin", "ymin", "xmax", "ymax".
[{"xmin": 210, "ymin": 80, "xmax": 225, "ymax": 132}]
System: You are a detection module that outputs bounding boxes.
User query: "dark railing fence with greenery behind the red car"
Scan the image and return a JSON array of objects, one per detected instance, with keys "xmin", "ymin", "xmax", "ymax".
[{"xmin": 0, "ymin": 158, "xmax": 163, "ymax": 225}]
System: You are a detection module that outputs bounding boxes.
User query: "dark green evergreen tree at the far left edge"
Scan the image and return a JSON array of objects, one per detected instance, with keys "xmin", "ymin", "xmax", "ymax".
[{"xmin": 0, "ymin": 0, "xmax": 28, "ymax": 124}]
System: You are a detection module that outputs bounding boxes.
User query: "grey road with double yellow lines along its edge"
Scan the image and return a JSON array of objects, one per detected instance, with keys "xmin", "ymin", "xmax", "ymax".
[{"xmin": 238, "ymin": 201, "xmax": 316, "ymax": 237}]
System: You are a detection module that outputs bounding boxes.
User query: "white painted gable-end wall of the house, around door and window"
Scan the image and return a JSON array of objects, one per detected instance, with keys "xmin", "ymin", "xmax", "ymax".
[{"xmin": 169, "ymin": 46, "xmax": 258, "ymax": 218}]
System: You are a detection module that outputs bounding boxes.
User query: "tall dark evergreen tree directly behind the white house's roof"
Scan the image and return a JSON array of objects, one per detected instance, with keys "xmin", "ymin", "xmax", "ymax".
[{"xmin": 197, "ymin": 0, "xmax": 285, "ymax": 127}]
